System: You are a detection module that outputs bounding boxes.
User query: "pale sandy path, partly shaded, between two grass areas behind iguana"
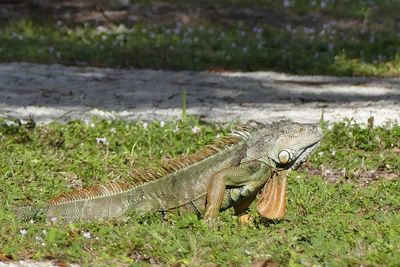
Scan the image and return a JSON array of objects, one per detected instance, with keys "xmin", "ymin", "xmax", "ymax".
[{"xmin": 0, "ymin": 63, "xmax": 400, "ymax": 124}]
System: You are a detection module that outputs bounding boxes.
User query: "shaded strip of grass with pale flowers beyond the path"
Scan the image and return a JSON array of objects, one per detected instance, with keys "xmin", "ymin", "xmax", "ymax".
[{"xmin": 0, "ymin": 0, "xmax": 400, "ymax": 76}]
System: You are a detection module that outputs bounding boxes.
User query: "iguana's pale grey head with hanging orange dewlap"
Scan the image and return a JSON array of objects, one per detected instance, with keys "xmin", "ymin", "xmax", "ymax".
[{"xmin": 247, "ymin": 121, "xmax": 322, "ymax": 222}]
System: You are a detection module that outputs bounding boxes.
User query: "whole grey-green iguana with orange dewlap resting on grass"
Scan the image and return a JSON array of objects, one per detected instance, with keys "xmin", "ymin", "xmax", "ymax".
[{"xmin": 17, "ymin": 121, "xmax": 322, "ymax": 220}]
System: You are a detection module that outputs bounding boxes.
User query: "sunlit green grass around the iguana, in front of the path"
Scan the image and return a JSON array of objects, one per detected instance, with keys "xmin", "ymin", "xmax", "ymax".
[{"xmin": 0, "ymin": 117, "xmax": 400, "ymax": 266}]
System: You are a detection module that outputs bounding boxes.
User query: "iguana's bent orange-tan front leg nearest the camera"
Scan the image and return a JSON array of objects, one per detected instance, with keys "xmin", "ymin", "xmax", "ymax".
[{"xmin": 204, "ymin": 160, "xmax": 269, "ymax": 220}]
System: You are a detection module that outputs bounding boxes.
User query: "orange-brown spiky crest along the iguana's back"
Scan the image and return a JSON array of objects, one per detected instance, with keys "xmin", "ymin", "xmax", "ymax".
[{"xmin": 49, "ymin": 124, "xmax": 260, "ymax": 205}]
